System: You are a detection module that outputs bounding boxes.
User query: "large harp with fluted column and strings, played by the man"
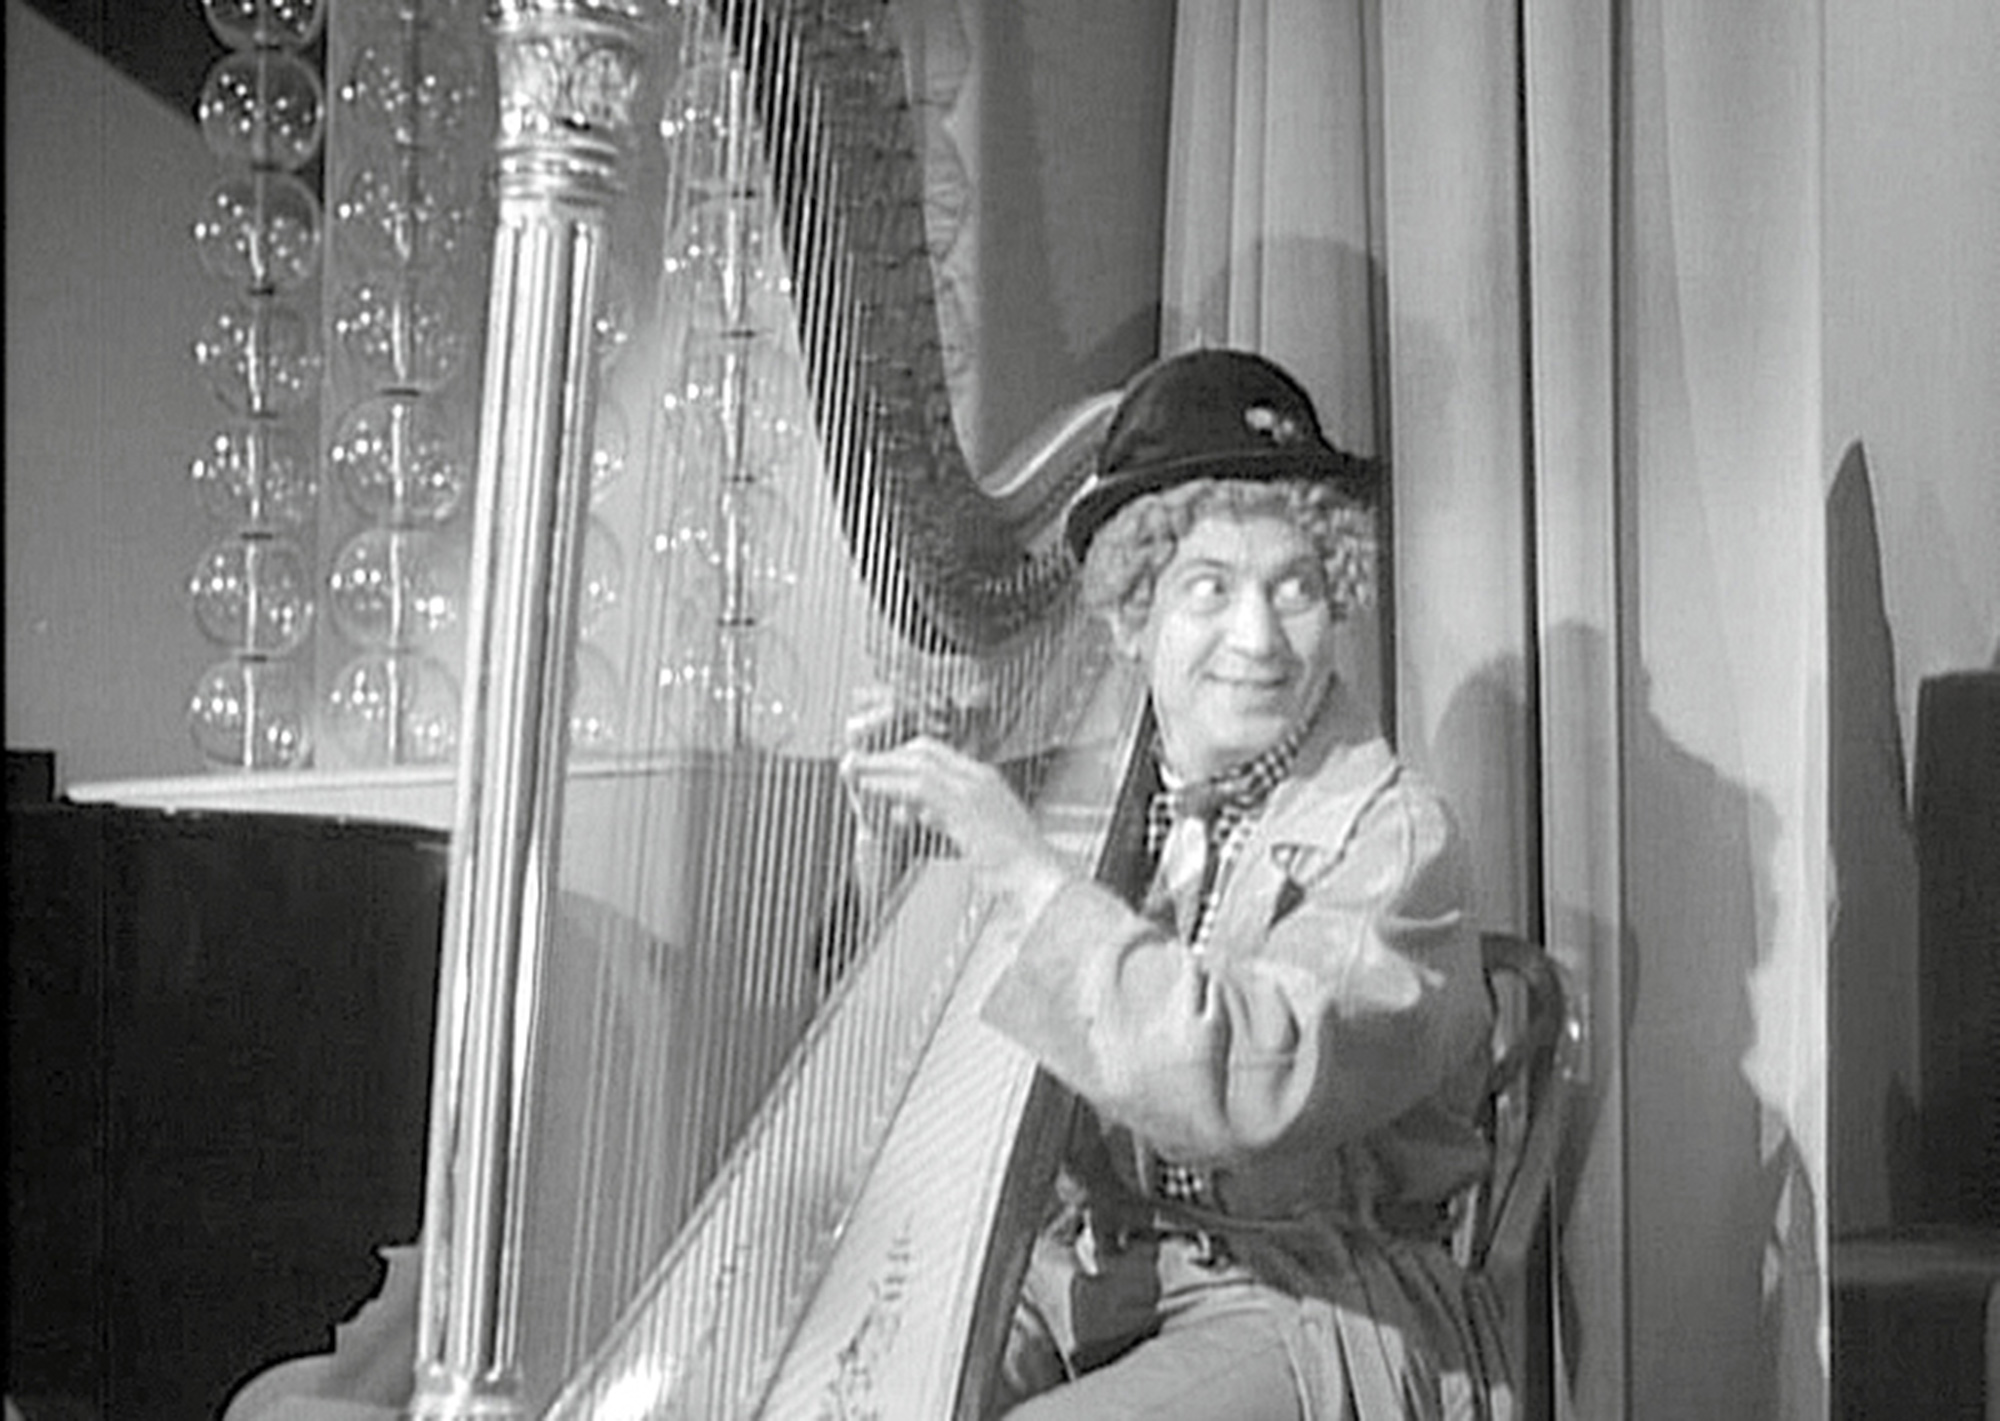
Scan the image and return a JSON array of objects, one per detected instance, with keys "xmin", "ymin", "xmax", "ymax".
[{"xmin": 412, "ymin": 0, "xmax": 1140, "ymax": 1417}]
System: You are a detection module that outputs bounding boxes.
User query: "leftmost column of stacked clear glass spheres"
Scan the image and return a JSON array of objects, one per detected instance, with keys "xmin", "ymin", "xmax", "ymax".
[{"xmin": 188, "ymin": 0, "xmax": 326, "ymax": 769}]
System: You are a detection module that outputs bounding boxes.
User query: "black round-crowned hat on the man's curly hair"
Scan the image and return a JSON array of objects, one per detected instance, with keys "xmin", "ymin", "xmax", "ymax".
[{"xmin": 1064, "ymin": 350, "xmax": 1374, "ymax": 560}]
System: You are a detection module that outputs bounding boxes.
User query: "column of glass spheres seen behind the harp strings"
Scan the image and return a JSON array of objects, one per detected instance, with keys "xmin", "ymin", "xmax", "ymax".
[{"xmin": 652, "ymin": 44, "xmax": 812, "ymax": 751}]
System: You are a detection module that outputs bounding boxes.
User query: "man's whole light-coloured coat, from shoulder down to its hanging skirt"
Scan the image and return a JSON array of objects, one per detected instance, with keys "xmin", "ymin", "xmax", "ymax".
[{"xmin": 984, "ymin": 690, "xmax": 1514, "ymax": 1421}]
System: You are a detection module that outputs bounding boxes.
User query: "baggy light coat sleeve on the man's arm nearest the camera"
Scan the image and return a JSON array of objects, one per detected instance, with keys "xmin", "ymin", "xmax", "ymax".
[{"xmin": 984, "ymin": 781, "xmax": 1488, "ymax": 1165}]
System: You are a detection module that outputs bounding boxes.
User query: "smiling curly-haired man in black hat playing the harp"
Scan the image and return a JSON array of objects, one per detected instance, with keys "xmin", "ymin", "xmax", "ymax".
[{"xmin": 842, "ymin": 350, "xmax": 1512, "ymax": 1421}]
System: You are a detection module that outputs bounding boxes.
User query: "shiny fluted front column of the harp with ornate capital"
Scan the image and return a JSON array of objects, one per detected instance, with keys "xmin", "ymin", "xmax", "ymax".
[{"xmin": 412, "ymin": 0, "xmax": 658, "ymax": 1421}]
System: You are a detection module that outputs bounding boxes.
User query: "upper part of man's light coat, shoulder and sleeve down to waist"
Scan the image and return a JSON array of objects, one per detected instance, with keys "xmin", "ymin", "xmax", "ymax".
[{"xmin": 984, "ymin": 690, "xmax": 1492, "ymax": 1227}]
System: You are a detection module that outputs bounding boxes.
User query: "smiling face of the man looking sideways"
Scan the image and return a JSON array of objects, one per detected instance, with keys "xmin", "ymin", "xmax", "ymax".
[{"xmin": 1118, "ymin": 514, "xmax": 1334, "ymax": 779}]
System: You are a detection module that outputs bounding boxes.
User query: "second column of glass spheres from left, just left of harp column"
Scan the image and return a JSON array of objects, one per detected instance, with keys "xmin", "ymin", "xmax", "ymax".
[{"xmin": 322, "ymin": 0, "xmax": 492, "ymax": 765}]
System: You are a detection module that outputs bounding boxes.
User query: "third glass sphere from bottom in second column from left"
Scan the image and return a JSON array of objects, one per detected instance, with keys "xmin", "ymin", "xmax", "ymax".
[{"xmin": 326, "ymin": 394, "xmax": 472, "ymax": 528}]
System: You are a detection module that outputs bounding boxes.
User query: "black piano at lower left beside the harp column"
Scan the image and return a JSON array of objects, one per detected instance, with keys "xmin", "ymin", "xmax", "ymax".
[{"xmin": 6, "ymin": 797, "xmax": 446, "ymax": 1421}]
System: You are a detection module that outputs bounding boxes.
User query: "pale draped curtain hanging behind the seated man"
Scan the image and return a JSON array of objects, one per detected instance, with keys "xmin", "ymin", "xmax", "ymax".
[{"xmin": 1162, "ymin": 0, "xmax": 1828, "ymax": 1417}]
